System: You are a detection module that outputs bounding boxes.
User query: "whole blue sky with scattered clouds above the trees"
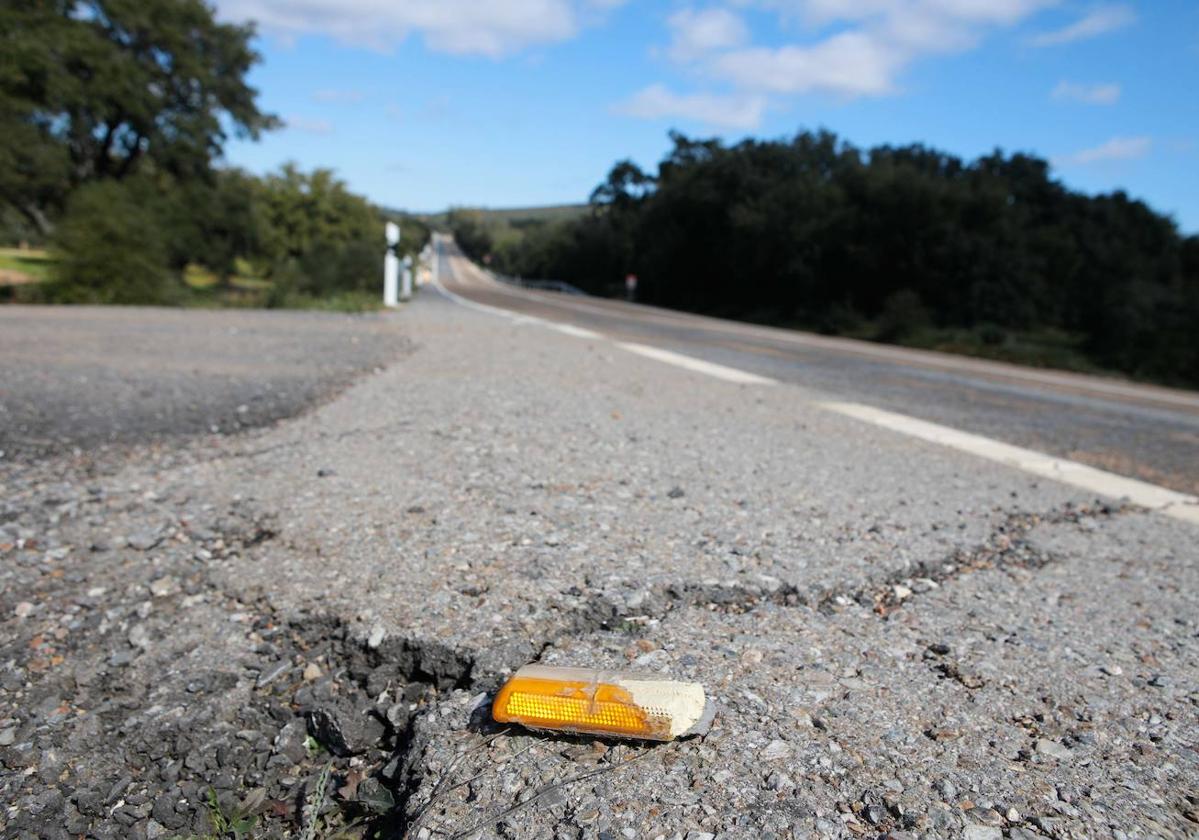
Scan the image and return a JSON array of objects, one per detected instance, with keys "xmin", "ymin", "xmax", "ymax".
[{"xmin": 216, "ymin": 0, "xmax": 1199, "ymax": 228}]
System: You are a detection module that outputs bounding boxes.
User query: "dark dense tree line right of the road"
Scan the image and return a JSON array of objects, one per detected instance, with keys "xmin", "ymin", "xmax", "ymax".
[{"xmin": 451, "ymin": 131, "xmax": 1199, "ymax": 385}]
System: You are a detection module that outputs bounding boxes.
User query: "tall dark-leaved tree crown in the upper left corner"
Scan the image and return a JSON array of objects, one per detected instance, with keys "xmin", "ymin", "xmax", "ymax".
[{"xmin": 0, "ymin": 0, "xmax": 278, "ymax": 231}]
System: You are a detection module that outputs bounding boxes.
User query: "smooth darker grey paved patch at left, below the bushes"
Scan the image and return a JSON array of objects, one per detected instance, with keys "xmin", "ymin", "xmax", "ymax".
[{"xmin": 0, "ymin": 306, "xmax": 406, "ymax": 461}]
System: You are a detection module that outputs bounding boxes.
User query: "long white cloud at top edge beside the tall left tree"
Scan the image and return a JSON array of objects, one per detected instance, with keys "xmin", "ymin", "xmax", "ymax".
[{"xmin": 218, "ymin": 0, "xmax": 622, "ymax": 58}]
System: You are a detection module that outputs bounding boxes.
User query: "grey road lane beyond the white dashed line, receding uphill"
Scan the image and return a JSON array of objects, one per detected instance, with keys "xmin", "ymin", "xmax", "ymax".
[{"xmin": 438, "ymin": 238, "xmax": 1199, "ymax": 494}]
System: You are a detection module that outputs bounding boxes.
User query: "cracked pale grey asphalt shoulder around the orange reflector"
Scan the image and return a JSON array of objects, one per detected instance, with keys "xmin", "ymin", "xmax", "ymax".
[{"xmin": 0, "ymin": 281, "xmax": 1199, "ymax": 840}]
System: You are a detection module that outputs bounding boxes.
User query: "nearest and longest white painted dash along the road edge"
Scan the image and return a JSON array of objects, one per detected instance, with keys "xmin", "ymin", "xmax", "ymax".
[{"xmin": 818, "ymin": 403, "xmax": 1199, "ymax": 525}]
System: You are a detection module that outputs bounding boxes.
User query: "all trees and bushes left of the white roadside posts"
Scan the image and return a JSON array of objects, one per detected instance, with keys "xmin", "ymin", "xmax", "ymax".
[{"xmin": 0, "ymin": 0, "xmax": 428, "ymax": 310}]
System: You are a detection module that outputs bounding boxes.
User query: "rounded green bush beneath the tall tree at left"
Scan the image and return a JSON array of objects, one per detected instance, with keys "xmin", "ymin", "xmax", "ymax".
[{"xmin": 46, "ymin": 181, "xmax": 179, "ymax": 304}]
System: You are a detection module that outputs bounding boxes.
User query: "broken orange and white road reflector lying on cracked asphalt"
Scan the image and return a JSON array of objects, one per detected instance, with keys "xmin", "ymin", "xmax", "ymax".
[{"xmin": 492, "ymin": 665, "xmax": 716, "ymax": 741}]
